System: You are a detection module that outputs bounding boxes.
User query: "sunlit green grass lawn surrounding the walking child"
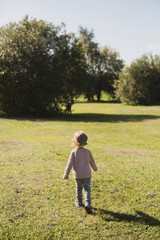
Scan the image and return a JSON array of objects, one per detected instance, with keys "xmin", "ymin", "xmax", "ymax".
[{"xmin": 0, "ymin": 103, "xmax": 160, "ymax": 240}]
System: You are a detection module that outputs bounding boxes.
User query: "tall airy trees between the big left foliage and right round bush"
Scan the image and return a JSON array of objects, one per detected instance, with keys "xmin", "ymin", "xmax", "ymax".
[{"xmin": 80, "ymin": 27, "xmax": 124, "ymax": 101}]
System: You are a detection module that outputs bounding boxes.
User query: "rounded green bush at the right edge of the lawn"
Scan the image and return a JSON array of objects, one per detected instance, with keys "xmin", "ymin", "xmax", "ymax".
[{"xmin": 115, "ymin": 55, "xmax": 160, "ymax": 105}]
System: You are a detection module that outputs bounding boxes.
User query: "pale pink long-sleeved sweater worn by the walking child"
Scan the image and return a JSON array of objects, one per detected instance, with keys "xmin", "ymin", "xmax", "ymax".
[{"xmin": 63, "ymin": 148, "xmax": 98, "ymax": 179}]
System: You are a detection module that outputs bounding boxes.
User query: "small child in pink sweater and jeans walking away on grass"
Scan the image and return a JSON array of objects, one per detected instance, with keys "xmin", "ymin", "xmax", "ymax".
[{"xmin": 63, "ymin": 131, "xmax": 98, "ymax": 214}]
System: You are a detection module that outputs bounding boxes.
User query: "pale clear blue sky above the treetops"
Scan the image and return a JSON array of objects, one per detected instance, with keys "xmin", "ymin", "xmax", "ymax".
[{"xmin": 0, "ymin": 0, "xmax": 160, "ymax": 65}]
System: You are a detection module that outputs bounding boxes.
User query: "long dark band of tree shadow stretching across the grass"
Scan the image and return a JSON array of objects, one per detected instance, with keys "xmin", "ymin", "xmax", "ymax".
[{"xmin": 0, "ymin": 113, "xmax": 160, "ymax": 122}]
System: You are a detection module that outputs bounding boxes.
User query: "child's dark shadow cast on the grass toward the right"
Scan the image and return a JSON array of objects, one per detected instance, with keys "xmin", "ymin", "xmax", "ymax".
[{"xmin": 93, "ymin": 208, "xmax": 160, "ymax": 226}]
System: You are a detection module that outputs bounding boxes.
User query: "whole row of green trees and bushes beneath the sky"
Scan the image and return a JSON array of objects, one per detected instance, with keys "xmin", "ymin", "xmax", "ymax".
[{"xmin": 0, "ymin": 16, "xmax": 160, "ymax": 115}]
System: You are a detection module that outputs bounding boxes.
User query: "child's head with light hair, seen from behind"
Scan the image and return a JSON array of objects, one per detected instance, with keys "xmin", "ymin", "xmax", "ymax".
[{"xmin": 73, "ymin": 131, "xmax": 88, "ymax": 148}]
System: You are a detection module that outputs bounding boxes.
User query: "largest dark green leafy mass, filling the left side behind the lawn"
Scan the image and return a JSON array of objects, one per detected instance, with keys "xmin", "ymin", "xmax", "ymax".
[{"xmin": 0, "ymin": 17, "xmax": 85, "ymax": 115}]
